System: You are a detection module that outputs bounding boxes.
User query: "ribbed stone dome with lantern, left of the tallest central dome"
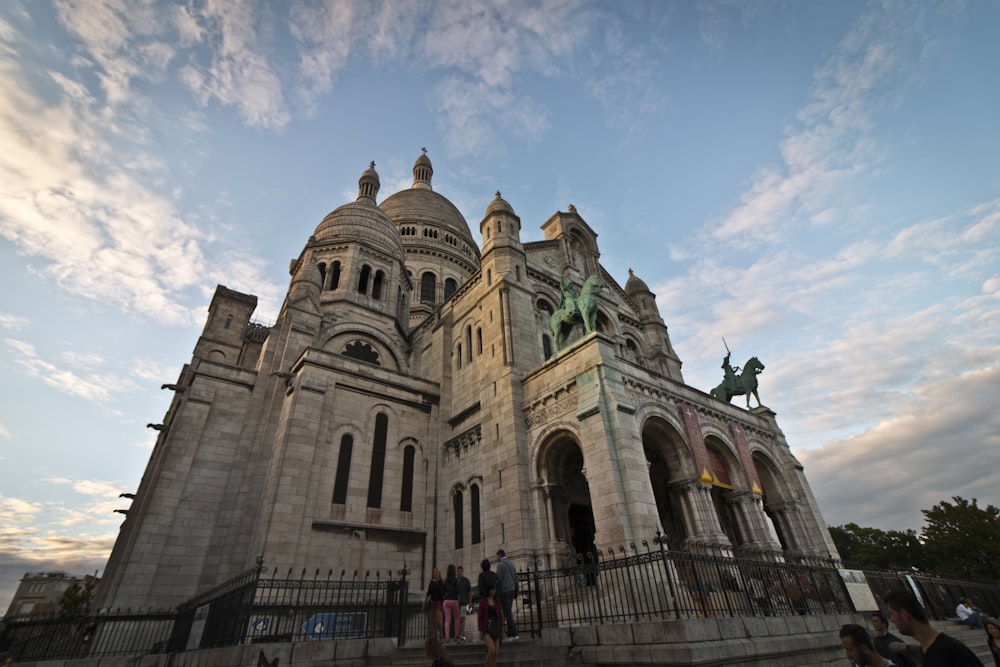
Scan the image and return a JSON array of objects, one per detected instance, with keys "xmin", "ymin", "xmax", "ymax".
[{"xmin": 313, "ymin": 162, "xmax": 404, "ymax": 258}]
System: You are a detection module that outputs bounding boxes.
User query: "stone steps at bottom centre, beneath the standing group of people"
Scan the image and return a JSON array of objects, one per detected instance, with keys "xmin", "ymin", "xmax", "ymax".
[{"xmin": 366, "ymin": 635, "xmax": 583, "ymax": 667}]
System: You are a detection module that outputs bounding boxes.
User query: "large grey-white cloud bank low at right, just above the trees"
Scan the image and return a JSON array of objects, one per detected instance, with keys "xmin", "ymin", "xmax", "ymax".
[{"xmin": 798, "ymin": 364, "xmax": 1000, "ymax": 530}]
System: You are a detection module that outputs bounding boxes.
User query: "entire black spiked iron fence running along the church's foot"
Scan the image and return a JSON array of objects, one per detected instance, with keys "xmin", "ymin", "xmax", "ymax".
[{"xmin": 0, "ymin": 535, "xmax": 1000, "ymax": 662}]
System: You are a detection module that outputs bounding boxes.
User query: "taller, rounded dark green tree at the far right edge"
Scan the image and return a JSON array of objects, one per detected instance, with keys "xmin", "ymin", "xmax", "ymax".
[{"xmin": 920, "ymin": 496, "xmax": 1000, "ymax": 581}]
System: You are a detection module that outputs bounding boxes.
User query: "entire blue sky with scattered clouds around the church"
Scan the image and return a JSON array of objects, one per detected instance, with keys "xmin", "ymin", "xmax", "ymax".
[{"xmin": 0, "ymin": 0, "xmax": 1000, "ymax": 599}]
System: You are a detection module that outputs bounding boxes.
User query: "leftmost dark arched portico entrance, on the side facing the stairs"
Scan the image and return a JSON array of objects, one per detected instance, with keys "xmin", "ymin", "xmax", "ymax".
[{"xmin": 538, "ymin": 431, "xmax": 597, "ymax": 560}]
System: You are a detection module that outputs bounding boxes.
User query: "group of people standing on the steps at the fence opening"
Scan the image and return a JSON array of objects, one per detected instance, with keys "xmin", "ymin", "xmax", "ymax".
[{"xmin": 424, "ymin": 549, "xmax": 518, "ymax": 667}]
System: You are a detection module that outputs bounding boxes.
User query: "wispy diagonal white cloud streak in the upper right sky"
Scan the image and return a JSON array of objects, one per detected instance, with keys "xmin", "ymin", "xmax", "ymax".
[{"xmin": 714, "ymin": 6, "xmax": 925, "ymax": 245}]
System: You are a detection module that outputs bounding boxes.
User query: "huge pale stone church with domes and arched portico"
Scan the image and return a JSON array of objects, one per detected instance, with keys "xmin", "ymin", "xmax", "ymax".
[{"xmin": 98, "ymin": 154, "xmax": 836, "ymax": 607}]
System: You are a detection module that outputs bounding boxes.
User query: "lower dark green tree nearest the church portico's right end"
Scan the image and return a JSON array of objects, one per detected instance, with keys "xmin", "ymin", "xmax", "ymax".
[{"xmin": 830, "ymin": 523, "xmax": 927, "ymax": 571}]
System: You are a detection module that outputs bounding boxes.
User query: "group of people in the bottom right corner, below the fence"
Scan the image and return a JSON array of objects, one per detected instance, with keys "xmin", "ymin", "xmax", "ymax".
[{"xmin": 840, "ymin": 591, "xmax": 1000, "ymax": 667}]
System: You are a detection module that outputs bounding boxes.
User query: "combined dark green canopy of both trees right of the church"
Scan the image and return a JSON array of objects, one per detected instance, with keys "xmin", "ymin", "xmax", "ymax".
[{"xmin": 830, "ymin": 496, "xmax": 1000, "ymax": 581}]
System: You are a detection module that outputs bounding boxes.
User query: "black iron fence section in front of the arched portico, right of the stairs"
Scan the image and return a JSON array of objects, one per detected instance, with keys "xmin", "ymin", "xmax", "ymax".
[{"xmin": 517, "ymin": 536, "xmax": 854, "ymax": 635}]
